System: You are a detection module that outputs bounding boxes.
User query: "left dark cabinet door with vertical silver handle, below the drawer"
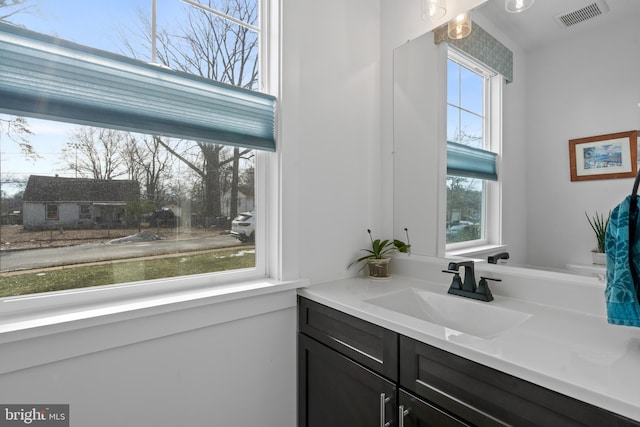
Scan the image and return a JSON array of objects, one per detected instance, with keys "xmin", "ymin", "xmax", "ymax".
[{"xmin": 298, "ymin": 334, "xmax": 397, "ymax": 427}]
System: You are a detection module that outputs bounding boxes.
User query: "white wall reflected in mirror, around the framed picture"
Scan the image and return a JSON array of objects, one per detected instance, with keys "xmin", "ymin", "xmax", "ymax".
[{"xmin": 525, "ymin": 16, "xmax": 640, "ymax": 268}]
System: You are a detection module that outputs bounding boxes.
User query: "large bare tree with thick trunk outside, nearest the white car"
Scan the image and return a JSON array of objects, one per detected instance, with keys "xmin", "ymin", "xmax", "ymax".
[{"xmin": 124, "ymin": 0, "xmax": 258, "ymax": 226}]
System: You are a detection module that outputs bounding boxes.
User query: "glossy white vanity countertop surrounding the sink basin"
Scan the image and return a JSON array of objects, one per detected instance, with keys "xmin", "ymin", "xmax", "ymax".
[{"xmin": 298, "ymin": 274, "xmax": 640, "ymax": 421}]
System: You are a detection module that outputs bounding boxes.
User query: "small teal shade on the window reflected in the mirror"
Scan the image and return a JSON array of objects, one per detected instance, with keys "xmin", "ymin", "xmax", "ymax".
[{"xmin": 447, "ymin": 141, "xmax": 498, "ymax": 181}]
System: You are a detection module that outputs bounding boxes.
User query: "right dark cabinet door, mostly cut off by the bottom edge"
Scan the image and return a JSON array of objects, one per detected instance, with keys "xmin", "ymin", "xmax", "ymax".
[{"xmin": 398, "ymin": 390, "xmax": 470, "ymax": 427}]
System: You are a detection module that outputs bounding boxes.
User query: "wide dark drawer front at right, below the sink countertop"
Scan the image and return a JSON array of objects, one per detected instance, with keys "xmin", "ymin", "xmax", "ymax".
[{"xmin": 400, "ymin": 337, "xmax": 640, "ymax": 427}]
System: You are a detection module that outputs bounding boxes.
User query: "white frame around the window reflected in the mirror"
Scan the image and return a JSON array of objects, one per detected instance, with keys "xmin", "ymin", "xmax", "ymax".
[{"xmin": 440, "ymin": 46, "xmax": 504, "ymax": 256}]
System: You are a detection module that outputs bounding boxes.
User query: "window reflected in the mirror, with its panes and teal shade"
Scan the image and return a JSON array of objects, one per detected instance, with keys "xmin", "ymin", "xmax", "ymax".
[{"xmin": 446, "ymin": 52, "xmax": 500, "ymax": 249}]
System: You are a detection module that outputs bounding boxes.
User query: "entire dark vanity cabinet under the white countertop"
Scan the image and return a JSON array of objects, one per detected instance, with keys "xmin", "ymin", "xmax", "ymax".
[{"xmin": 298, "ymin": 297, "xmax": 640, "ymax": 427}]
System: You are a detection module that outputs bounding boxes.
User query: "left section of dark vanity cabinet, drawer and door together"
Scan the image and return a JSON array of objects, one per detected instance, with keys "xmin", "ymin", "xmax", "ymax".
[{"xmin": 298, "ymin": 298, "xmax": 398, "ymax": 427}]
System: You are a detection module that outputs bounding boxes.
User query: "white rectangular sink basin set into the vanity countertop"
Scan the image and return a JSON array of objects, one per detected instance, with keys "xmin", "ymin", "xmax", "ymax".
[{"xmin": 364, "ymin": 289, "xmax": 531, "ymax": 339}]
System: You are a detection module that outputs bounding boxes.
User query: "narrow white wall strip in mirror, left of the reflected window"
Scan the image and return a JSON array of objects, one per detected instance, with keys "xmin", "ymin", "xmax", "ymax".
[{"xmin": 393, "ymin": 32, "xmax": 447, "ymax": 256}]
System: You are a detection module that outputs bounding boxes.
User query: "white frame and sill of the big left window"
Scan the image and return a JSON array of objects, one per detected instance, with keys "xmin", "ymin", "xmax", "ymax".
[{"xmin": 0, "ymin": 0, "xmax": 282, "ymax": 324}]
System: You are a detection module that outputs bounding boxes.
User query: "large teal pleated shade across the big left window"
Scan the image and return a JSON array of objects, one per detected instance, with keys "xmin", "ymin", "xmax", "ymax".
[{"xmin": 0, "ymin": 23, "xmax": 275, "ymax": 151}]
